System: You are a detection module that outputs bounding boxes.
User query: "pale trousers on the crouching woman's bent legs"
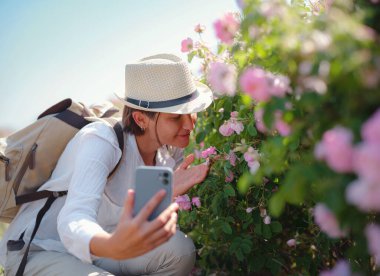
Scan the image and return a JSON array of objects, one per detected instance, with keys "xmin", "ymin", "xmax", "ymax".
[{"xmin": 5, "ymin": 230, "xmax": 195, "ymax": 276}]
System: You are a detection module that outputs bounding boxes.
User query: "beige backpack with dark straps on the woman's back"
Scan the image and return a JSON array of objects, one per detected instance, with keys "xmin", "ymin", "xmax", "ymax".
[{"xmin": 0, "ymin": 99, "xmax": 123, "ymax": 223}]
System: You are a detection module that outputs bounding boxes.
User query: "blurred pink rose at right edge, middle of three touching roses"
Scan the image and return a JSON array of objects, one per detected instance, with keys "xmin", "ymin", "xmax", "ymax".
[{"xmin": 353, "ymin": 142, "xmax": 380, "ymax": 183}]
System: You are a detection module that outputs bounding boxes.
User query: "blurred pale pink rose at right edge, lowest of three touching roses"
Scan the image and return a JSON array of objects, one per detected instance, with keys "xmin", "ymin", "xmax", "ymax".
[{"xmin": 346, "ymin": 178, "xmax": 380, "ymax": 212}]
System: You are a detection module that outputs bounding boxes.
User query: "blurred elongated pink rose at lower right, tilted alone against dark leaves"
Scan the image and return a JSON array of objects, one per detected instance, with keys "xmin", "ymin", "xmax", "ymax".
[{"xmin": 314, "ymin": 203, "xmax": 345, "ymax": 238}]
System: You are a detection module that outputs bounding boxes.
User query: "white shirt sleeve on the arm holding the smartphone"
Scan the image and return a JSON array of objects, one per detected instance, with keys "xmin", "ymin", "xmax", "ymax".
[{"xmin": 57, "ymin": 122, "xmax": 121, "ymax": 263}]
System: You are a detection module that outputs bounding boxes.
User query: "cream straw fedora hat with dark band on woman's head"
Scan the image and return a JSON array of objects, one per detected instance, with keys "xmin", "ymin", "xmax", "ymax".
[{"xmin": 116, "ymin": 54, "xmax": 213, "ymax": 114}]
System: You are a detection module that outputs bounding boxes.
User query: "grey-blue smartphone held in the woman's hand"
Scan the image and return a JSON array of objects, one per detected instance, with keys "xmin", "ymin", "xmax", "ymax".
[{"xmin": 133, "ymin": 166, "xmax": 173, "ymax": 220}]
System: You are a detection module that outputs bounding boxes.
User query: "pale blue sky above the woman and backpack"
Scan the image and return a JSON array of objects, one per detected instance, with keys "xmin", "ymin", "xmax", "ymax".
[{"xmin": 0, "ymin": 0, "xmax": 238, "ymax": 130}]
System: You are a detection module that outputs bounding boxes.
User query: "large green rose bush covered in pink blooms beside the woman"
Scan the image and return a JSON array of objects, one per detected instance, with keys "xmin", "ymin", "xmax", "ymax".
[{"xmin": 179, "ymin": 0, "xmax": 380, "ymax": 275}]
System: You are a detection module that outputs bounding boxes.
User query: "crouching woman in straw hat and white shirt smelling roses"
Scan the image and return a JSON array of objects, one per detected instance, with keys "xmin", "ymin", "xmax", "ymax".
[{"xmin": 0, "ymin": 54, "xmax": 212, "ymax": 275}]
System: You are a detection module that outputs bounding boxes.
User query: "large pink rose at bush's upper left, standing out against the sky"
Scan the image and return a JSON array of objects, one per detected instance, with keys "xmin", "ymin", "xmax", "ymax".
[{"xmin": 214, "ymin": 13, "xmax": 240, "ymax": 44}]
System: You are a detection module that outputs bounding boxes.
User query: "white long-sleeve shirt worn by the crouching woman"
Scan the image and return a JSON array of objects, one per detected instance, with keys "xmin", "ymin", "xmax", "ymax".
[{"xmin": 0, "ymin": 122, "xmax": 183, "ymax": 265}]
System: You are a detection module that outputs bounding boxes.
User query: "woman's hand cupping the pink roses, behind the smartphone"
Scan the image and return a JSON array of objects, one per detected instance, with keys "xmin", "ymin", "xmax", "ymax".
[{"xmin": 173, "ymin": 154, "xmax": 210, "ymax": 197}]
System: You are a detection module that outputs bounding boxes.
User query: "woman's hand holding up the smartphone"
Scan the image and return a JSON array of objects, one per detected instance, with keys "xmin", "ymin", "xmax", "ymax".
[{"xmin": 90, "ymin": 190, "xmax": 178, "ymax": 260}]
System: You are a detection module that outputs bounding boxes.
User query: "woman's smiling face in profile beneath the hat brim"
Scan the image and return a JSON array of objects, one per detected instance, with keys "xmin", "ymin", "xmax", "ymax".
[{"xmin": 149, "ymin": 113, "xmax": 197, "ymax": 148}]
